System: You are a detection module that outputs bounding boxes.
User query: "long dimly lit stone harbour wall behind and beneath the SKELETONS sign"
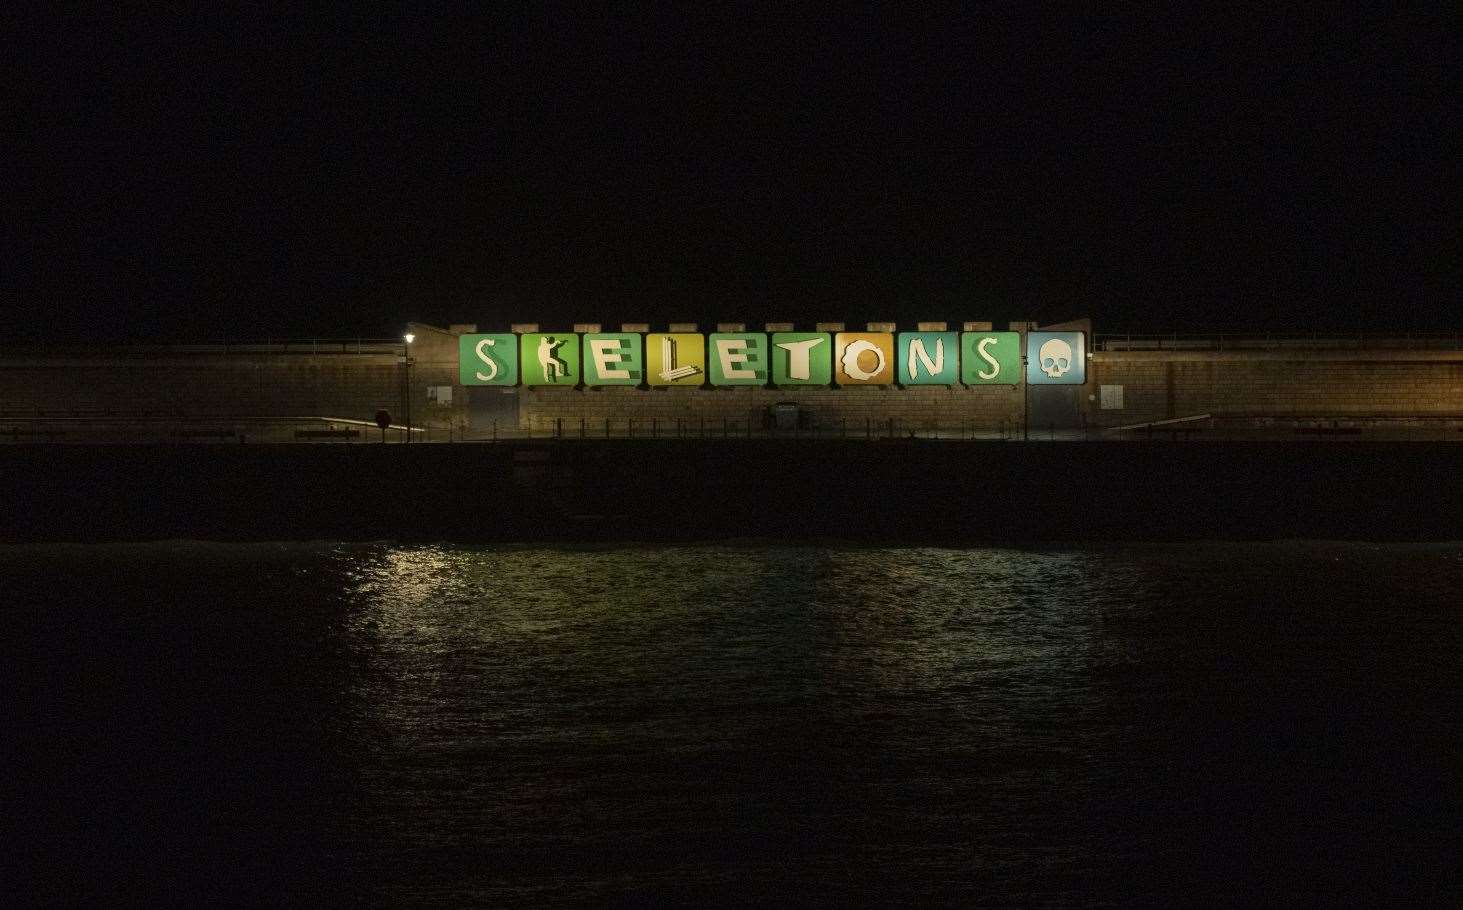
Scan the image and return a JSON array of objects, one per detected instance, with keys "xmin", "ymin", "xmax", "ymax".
[{"xmin": 0, "ymin": 323, "xmax": 1463, "ymax": 440}]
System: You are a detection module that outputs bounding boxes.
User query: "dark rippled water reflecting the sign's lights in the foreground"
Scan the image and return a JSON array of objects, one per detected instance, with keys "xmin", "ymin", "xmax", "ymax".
[{"xmin": 11, "ymin": 543, "xmax": 1463, "ymax": 904}]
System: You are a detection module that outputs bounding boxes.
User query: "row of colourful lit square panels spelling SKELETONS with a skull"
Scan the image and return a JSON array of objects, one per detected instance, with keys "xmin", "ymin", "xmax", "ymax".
[{"xmin": 458, "ymin": 326, "xmax": 1087, "ymax": 388}]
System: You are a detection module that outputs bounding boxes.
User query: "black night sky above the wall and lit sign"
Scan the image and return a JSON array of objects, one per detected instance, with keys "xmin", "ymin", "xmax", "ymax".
[{"xmin": 0, "ymin": 3, "xmax": 1463, "ymax": 341}]
